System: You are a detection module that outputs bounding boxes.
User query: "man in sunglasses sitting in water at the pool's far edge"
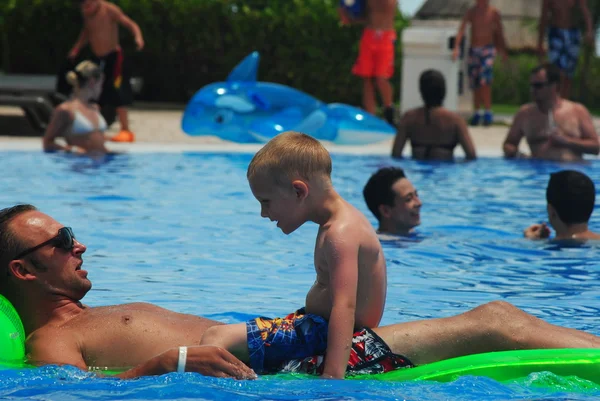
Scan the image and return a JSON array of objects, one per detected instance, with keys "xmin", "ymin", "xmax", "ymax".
[{"xmin": 503, "ymin": 64, "xmax": 600, "ymax": 161}]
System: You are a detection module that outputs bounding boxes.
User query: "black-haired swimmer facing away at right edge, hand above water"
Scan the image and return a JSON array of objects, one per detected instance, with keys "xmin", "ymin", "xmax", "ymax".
[{"xmin": 523, "ymin": 170, "xmax": 600, "ymax": 241}]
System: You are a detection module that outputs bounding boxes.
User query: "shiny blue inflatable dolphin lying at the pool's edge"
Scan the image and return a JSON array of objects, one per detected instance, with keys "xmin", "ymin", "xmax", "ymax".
[{"xmin": 181, "ymin": 52, "xmax": 396, "ymax": 145}]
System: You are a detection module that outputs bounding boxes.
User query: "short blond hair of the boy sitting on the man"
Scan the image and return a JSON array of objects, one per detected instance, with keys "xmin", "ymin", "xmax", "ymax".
[{"xmin": 247, "ymin": 131, "xmax": 331, "ymax": 185}]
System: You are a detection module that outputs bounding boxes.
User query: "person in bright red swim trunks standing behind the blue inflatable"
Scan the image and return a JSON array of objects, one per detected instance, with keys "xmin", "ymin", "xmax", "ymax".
[{"xmin": 338, "ymin": 0, "xmax": 398, "ymax": 125}]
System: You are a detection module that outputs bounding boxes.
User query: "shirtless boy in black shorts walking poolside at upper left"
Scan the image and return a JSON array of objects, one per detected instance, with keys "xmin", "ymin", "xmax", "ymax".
[{"xmin": 69, "ymin": 0, "xmax": 144, "ymax": 142}]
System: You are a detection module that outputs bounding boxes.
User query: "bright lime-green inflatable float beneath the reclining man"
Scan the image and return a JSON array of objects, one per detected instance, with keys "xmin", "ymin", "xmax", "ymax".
[{"xmin": 0, "ymin": 295, "xmax": 600, "ymax": 385}]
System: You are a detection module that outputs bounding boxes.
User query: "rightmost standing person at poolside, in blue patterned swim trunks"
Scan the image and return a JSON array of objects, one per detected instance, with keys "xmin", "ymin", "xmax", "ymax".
[{"xmin": 538, "ymin": 0, "xmax": 594, "ymax": 99}]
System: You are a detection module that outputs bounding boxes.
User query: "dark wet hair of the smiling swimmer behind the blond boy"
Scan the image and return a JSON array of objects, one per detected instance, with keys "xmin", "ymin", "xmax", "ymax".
[{"xmin": 363, "ymin": 167, "xmax": 406, "ymax": 221}]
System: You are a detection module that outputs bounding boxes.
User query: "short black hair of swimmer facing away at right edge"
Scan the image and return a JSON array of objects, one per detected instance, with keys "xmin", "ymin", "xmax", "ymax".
[{"xmin": 546, "ymin": 170, "xmax": 596, "ymax": 225}]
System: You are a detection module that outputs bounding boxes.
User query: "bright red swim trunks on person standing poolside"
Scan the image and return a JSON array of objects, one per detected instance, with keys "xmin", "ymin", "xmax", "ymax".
[{"xmin": 352, "ymin": 28, "xmax": 397, "ymax": 78}]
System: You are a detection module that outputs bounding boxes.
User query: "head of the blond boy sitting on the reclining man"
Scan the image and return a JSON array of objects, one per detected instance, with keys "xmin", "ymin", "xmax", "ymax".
[{"xmin": 247, "ymin": 131, "xmax": 331, "ymax": 234}]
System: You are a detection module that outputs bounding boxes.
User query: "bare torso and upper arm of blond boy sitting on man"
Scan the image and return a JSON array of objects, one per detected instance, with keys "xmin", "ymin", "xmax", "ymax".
[{"xmin": 306, "ymin": 197, "xmax": 387, "ymax": 328}]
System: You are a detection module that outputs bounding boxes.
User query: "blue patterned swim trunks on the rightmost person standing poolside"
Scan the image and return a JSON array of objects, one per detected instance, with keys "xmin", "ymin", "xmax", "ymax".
[{"xmin": 548, "ymin": 27, "xmax": 581, "ymax": 77}]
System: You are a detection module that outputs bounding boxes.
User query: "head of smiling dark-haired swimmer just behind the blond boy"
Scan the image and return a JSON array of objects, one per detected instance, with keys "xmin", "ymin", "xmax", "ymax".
[{"xmin": 363, "ymin": 167, "xmax": 422, "ymax": 236}]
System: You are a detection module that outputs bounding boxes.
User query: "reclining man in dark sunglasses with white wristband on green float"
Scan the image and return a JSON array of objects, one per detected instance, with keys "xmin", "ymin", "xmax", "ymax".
[{"xmin": 0, "ymin": 205, "xmax": 600, "ymax": 379}]
